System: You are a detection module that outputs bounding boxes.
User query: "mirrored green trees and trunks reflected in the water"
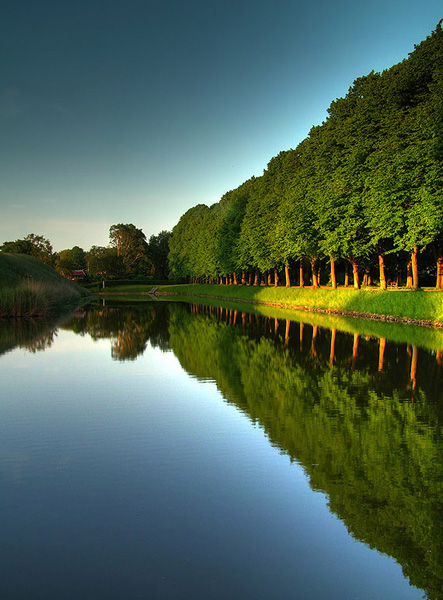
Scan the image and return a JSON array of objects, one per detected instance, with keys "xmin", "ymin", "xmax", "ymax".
[{"xmin": 3, "ymin": 302, "xmax": 443, "ymax": 600}]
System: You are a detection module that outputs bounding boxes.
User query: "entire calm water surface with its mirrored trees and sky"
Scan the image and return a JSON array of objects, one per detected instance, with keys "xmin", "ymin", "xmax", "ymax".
[{"xmin": 0, "ymin": 302, "xmax": 443, "ymax": 600}]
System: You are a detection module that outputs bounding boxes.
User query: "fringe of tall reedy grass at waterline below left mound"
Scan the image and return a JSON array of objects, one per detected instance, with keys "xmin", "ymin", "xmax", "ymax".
[{"xmin": 0, "ymin": 279, "xmax": 86, "ymax": 317}]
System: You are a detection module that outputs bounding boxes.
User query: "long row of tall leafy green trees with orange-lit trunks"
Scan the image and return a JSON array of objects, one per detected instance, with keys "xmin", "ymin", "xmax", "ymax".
[{"xmin": 169, "ymin": 22, "xmax": 443, "ymax": 289}]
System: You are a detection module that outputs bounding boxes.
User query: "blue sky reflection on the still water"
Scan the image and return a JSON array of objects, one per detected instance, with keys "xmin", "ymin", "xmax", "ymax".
[{"xmin": 0, "ymin": 322, "xmax": 421, "ymax": 600}]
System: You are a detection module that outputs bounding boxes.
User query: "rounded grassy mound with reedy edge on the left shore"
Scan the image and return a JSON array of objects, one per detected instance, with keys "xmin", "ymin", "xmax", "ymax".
[{"xmin": 0, "ymin": 253, "xmax": 90, "ymax": 317}]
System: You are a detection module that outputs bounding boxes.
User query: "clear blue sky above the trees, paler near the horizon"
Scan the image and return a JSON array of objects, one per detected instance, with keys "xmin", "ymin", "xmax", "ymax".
[{"xmin": 0, "ymin": 0, "xmax": 443, "ymax": 250}]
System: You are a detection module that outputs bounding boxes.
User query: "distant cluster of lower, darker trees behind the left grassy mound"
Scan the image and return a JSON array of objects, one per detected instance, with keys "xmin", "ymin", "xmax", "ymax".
[{"xmin": 0, "ymin": 223, "xmax": 171, "ymax": 279}]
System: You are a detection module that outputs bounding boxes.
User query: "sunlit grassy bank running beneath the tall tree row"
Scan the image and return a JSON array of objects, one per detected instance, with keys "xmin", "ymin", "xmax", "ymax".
[{"xmin": 96, "ymin": 284, "xmax": 443, "ymax": 327}]
